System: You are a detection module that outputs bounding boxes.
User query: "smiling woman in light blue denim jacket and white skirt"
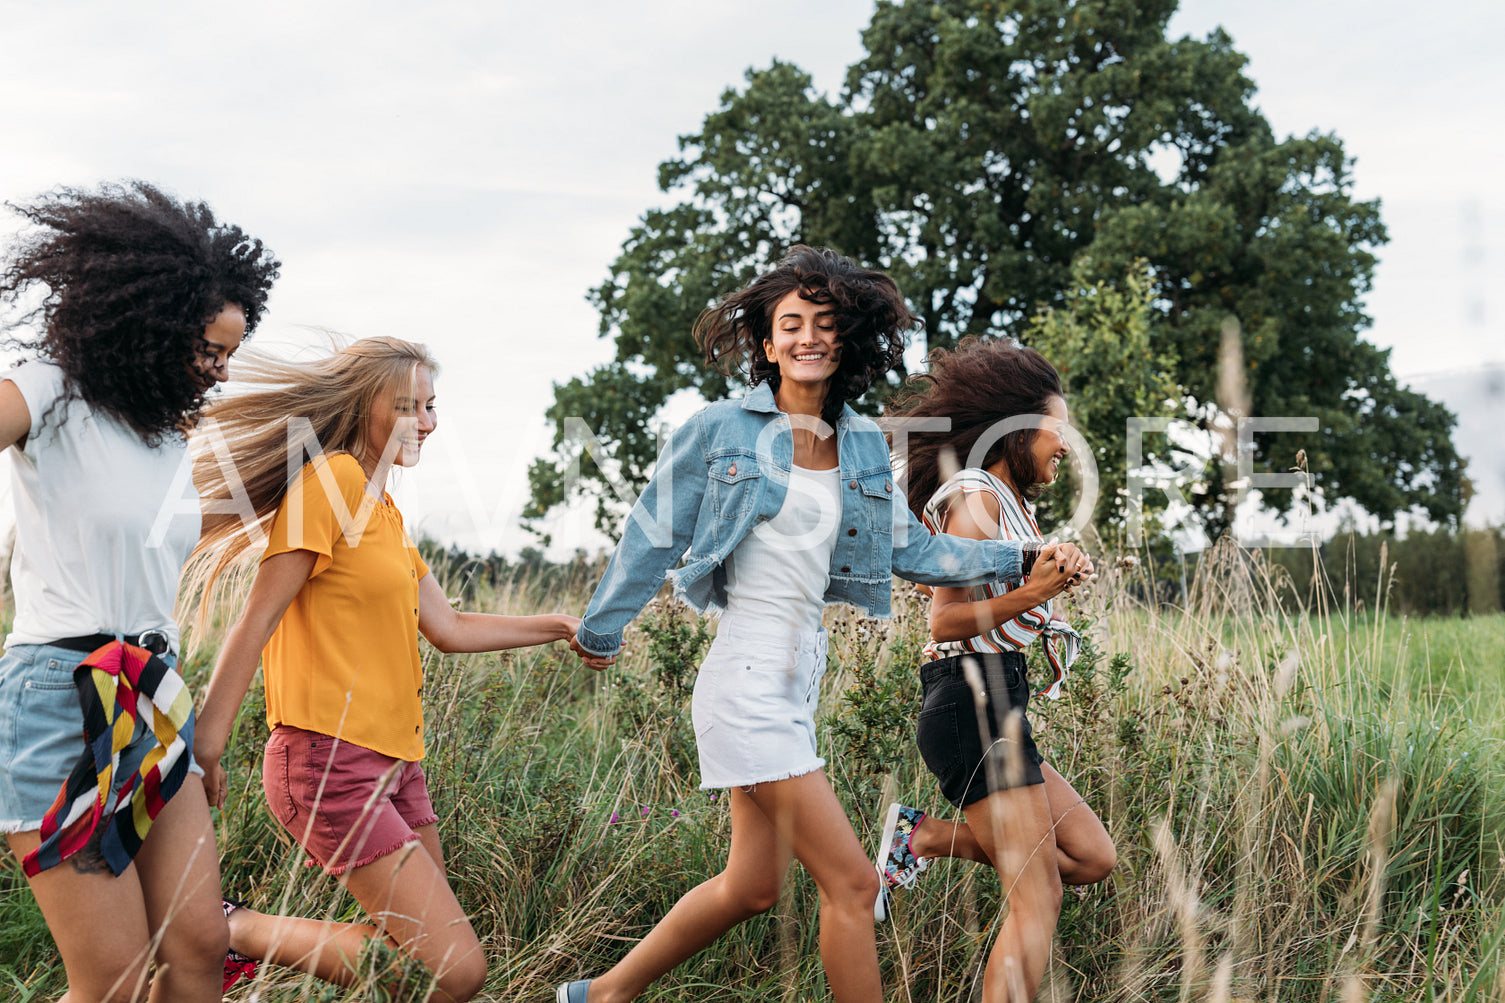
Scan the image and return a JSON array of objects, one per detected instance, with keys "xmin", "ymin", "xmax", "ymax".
[{"xmin": 557, "ymin": 247, "xmax": 1090, "ymax": 1003}]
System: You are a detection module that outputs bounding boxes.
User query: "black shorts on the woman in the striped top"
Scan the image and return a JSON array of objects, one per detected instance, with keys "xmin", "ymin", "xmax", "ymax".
[{"xmin": 915, "ymin": 651, "xmax": 1044, "ymax": 807}]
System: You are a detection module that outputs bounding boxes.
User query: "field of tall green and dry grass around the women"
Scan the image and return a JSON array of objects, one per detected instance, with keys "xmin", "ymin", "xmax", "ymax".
[{"xmin": 0, "ymin": 551, "xmax": 1505, "ymax": 1003}]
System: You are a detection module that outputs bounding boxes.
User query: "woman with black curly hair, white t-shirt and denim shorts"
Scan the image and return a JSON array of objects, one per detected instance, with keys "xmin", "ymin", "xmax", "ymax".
[{"xmin": 0, "ymin": 182, "xmax": 278, "ymax": 1003}]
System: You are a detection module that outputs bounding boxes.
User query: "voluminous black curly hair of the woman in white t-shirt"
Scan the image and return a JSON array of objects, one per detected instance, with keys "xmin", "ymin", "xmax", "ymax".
[{"xmin": 0, "ymin": 181, "xmax": 280, "ymax": 446}]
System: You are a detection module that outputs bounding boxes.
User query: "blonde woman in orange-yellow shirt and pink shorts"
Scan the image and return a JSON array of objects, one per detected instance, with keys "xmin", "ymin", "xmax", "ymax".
[{"xmin": 190, "ymin": 337, "xmax": 607, "ymax": 1000}]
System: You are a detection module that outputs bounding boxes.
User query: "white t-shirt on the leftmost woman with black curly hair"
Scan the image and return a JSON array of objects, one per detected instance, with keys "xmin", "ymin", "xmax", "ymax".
[{"xmin": 0, "ymin": 361, "xmax": 200, "ymax": 649}]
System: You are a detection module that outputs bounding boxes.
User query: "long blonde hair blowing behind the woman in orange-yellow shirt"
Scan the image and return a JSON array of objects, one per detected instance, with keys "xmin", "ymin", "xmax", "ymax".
[{"xmin": 179, "ymin": 337, "xmax": 438, "ymax": 636}]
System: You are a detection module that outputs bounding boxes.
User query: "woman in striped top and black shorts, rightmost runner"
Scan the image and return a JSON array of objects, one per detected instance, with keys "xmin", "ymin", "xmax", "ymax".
[{"xmin": 879, "ymin": 342, "xmax": 1117, "ymax": 1001}]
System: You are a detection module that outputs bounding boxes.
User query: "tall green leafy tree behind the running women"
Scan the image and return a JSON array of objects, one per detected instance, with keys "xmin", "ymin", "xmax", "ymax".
[{"xmin": 528, "ymin": 0, "xmax": 1463, "ymax": 533}]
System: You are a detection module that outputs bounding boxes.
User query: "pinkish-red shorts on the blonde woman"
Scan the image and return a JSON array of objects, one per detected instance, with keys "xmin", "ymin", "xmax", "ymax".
[{"xmin": 262, "ymin": 724, "xmax": 439, "ymax": 873}]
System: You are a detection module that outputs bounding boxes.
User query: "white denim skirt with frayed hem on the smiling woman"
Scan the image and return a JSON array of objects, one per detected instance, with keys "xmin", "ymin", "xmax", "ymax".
[{"xmin": 689, "ymin": 616, "xmax": 826, "ymax": 791}]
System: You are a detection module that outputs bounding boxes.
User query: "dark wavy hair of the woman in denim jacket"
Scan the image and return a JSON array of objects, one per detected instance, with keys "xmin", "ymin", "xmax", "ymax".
[{"xmin": 695, "ymin": 244, "xmax": 918, "ymax": 426}]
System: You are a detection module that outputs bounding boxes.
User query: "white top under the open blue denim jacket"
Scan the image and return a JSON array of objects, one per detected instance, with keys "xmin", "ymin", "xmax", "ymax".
[{"xmin": 727, "ymin": 467, "xmax": 841, "ymax": 634}]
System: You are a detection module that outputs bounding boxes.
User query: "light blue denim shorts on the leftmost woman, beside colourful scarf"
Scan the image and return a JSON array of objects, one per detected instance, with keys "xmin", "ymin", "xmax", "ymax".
[{"xmin": 0, "ymin": 645, "xmax": 203, "ymax": 833}]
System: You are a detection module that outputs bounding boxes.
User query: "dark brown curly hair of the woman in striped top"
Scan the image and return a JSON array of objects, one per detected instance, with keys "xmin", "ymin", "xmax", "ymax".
[{"xmin": 885, "ymin": 337, "xmax": 1066, "ymax": 518}]
